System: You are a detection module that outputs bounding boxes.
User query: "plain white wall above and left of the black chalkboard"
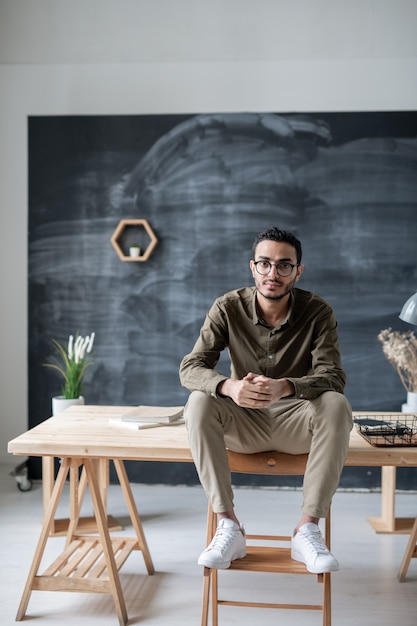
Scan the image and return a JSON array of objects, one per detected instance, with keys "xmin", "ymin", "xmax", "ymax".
[{"xmin": 0, "ymin": 0, "xmax": 417, "ymax": 464}]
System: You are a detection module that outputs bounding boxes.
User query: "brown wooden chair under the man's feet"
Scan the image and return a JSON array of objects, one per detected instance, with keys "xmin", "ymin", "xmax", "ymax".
[{"xmin": 201, "ymin": 451, "xmax": 331, "ymax": 626}]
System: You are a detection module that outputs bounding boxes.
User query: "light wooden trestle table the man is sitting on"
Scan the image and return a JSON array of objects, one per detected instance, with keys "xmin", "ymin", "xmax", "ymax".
[{"xmin": 8, "ymin": 406, "xmax": 417, "ymax": 626}]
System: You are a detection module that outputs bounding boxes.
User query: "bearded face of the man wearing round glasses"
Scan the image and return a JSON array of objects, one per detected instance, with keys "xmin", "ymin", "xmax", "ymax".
[{"xmin": 250, "ymin": 240, "xmax": 304, "ymax": 300}]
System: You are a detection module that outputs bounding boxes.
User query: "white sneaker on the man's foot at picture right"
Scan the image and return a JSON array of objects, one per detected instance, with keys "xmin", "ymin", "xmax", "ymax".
[{"xmin": 291, "ymin": 522, "xmax": 339, "ymax": 574}]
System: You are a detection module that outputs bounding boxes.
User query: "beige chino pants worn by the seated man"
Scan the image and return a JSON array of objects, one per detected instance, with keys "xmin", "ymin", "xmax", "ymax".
[{"xmin": 184, "ymin": 391, "xmax": 353, "ymax": 518}]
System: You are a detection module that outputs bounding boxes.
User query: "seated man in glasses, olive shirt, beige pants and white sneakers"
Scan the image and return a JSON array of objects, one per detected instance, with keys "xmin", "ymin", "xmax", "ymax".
[{"xmin": 180, "ymin": 228, "xmax": 352, "ymax": 573}]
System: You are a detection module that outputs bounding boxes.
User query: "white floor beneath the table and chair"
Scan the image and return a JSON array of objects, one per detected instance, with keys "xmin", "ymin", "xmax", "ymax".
[{"xmin": 0, "ymin": 458, "xmax": 417, "ymax": 626}]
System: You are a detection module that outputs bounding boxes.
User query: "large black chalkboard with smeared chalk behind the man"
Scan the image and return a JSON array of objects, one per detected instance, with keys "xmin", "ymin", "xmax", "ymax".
[{"xmin": 28, "ymin": 112, "xmax": 417, "ymax": 488}]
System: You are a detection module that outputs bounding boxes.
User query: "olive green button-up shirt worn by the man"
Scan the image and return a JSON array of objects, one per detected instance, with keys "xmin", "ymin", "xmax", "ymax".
[{"xmin": 180, "ymin": 287, "xmax": 346, "ymax": 400}]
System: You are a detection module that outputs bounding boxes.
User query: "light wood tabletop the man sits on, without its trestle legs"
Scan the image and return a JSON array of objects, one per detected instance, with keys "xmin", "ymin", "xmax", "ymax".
[{"xmin": 8, "ymin": 405, "xmax": 417, "ymax": 467}]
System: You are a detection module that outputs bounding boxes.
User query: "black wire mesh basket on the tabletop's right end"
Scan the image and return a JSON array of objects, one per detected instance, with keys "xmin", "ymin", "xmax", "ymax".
[{"xmin": 354, "ymin": 413, "xmax": 417, "ymax": 447}]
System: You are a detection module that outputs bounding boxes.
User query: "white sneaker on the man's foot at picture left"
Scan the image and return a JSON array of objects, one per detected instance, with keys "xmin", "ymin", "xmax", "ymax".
[{"xmin": 198, "ymin": 517, "xmax": 246, "ymax": 569}]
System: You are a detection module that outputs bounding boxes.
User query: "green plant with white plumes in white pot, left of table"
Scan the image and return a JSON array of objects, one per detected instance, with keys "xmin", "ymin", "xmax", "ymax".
[{"xmin": 44, "ymin": 333, "xmax": 95, "ymax": 415}]
